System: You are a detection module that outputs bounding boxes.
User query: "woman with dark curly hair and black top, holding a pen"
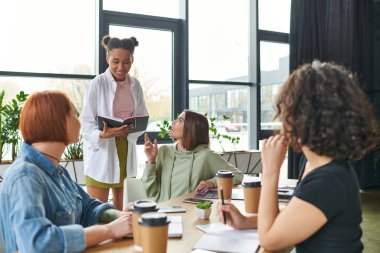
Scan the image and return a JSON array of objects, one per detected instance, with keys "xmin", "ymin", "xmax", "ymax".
[{"xmin": 221, "ymin": 61, "xmax": 377, "ymax": 253}]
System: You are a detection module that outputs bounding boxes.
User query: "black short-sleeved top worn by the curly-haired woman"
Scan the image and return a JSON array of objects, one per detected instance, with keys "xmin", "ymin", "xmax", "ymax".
[{"xmin": 294, "ymin": 161, "xmax": 363, "ymax": 253}]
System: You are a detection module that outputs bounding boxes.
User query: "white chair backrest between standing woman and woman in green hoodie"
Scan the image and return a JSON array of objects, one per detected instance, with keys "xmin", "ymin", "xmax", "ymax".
[{"xmin": 123, "ymin": 178, "xmax": 148, "ymax": 206}]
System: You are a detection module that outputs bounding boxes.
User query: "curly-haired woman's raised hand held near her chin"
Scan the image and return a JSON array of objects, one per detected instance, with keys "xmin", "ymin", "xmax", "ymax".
[{"xmin": 261, "ymin": 134, "xmax": 288, "ymax": 174}]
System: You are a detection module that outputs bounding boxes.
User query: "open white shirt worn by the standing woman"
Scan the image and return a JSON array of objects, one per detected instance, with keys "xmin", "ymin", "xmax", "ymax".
[{"xmin": 80, "ymin": 69, "xmax": 148, "ymax": 184}]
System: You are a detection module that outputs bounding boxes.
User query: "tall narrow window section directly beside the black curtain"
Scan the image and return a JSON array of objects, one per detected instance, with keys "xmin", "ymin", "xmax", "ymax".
[{"xmin": 257, "ymin": 0, "xmax": 291, "ymax": 134}]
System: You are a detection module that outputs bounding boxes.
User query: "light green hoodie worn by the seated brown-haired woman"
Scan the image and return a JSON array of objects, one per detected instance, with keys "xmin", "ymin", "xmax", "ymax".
[{"xmin": 142, "ymin": 144, "xmax": 244, "ymax": 202}]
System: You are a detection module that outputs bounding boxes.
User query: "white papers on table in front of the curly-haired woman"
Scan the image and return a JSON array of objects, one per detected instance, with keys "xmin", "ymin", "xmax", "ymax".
[{"xmin": 193, "ymin": 223, "xmax": 259, "ymax": 253}]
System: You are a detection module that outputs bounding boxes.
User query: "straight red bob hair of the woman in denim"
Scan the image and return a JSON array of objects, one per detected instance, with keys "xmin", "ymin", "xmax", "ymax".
[{"xmin": 19, "ymin": 91, "xmax": 72, "ymax": 145}]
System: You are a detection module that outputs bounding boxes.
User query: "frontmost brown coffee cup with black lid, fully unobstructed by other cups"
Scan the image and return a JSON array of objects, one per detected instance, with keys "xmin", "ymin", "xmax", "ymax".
[{"xmin": 139, "ymin": 212, "xmax": 170, "ymax": 253}]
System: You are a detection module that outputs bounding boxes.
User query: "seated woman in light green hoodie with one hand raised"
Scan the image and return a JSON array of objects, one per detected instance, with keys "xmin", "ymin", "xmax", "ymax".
[{"xmin": 142, "ymin": 110, "xmax": 243, "ymax": 202}]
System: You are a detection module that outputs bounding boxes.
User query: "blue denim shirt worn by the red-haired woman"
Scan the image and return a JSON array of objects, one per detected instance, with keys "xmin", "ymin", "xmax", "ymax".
[{"xmin": 0, "ymin": 143, "xmax": 114, "ymax": 253}]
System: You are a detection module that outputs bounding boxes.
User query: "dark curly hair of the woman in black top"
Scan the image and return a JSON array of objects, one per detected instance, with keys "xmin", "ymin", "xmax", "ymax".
[{"xmin": 276, "ymin": 61, "xmax": 378, "ymax": 160}]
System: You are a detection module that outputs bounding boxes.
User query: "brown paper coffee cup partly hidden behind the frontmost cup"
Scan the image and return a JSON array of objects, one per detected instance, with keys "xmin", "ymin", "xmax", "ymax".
[{"xmin": 131, "ymin": 200, "xmax": 158, "ymax": 251}]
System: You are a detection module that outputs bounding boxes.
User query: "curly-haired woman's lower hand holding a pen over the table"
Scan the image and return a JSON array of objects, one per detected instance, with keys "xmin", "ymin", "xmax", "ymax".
[{"xmin": 219, "ymin": 203, "xmax": 257, "ymax": 229}]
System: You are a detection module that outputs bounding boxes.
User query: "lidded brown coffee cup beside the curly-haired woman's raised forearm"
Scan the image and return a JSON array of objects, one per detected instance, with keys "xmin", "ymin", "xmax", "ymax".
[{"xmin": 243, "ymin": 180, "xmax": 261, "ymax": 215}]
